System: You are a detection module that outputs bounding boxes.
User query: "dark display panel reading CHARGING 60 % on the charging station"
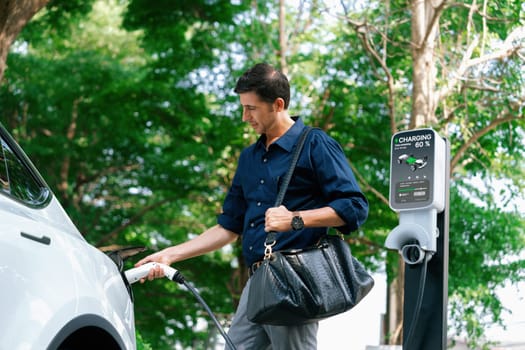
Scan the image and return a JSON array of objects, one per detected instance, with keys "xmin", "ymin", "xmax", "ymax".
[{"xmin": 390, "ymin": 129, "xmax": 438, "ymax": 210}]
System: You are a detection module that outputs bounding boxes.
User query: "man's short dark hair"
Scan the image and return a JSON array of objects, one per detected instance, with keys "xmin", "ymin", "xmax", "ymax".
[{"xmin": 234, "ymin": 63, "xmax": 290, "ymax": 109}]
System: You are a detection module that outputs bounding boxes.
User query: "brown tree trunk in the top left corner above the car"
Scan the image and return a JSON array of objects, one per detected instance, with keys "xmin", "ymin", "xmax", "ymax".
[{"xmin": 0, "ymin": 0, "xmax": 49, "ymax": 83}]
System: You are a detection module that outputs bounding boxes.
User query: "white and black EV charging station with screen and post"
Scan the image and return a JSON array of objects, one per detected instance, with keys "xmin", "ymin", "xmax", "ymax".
[{"xmin": 385, "ymin": 129, "xmax": 450, "ymax": 350}]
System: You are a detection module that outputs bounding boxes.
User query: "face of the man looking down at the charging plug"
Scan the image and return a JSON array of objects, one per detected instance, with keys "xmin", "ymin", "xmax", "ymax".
[{"xmin": 239, "ymin": 92, "xmax": 276, "ymax": 135}]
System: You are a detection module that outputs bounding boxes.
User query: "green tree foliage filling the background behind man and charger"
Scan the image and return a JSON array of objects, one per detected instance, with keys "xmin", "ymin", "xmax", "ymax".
[{"xmin": 0, "ymin": 0, "xmax": 525, "ymax": 349}]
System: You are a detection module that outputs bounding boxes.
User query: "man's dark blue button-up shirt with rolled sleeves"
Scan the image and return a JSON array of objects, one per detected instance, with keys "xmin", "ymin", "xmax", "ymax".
[{"xmin": 218, "ymin": 119, "xmax": 368, "ymax": 266}]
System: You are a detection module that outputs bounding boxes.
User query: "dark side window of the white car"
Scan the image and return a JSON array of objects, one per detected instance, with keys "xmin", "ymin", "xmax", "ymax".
[{"xmin": 0, "ymin": 139, "xmax": 48, "ymax": 205}]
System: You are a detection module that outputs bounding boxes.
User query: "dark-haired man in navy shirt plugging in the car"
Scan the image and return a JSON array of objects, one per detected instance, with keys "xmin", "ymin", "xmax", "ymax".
[{"xmin": 137, "ymin": 63, "xmax": 368, "ymax": 350}]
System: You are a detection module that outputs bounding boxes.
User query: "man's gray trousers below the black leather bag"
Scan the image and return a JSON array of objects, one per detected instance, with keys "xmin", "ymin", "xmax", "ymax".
[{"xmin": 226, "ymin": 279, "xmax": 319, "ymax": 350}]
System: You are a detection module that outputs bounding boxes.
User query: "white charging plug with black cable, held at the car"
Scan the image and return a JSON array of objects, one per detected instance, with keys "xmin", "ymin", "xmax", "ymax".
[{"xmin": 124, "ymin": 262, "xmax": 236, "ymax": 350}]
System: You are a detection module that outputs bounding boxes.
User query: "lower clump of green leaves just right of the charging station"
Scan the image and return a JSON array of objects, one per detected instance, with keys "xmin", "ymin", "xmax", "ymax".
[{"xmin": 449, "ymin": 182, "xmax": 525, "ymax": 348}]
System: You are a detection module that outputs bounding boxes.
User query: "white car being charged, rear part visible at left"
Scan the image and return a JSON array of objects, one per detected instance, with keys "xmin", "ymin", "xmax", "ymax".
[{"xmin": 0, "ymin": 124, "xmax": 136, "ymax": 350}]
